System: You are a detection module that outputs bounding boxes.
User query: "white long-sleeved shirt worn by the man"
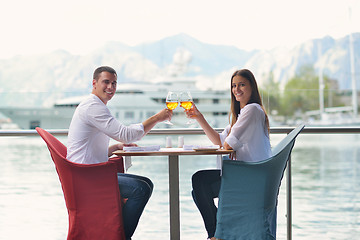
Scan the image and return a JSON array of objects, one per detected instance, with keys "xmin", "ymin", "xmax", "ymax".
[{"xmin": 67, "ymin": 94, "xmax": 145, "ymax": 164}]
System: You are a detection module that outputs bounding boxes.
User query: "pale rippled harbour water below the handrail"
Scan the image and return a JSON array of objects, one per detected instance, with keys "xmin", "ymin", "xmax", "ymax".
[{"xmin": 0, "ymin": 134, "xmax": 360, "ymax": 240}]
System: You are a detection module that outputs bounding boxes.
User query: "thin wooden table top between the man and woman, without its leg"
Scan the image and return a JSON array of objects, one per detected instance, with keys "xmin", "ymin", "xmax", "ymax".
[{"xmin": 113, "ymin": 148, "xmax": 233, "ymax": 156}]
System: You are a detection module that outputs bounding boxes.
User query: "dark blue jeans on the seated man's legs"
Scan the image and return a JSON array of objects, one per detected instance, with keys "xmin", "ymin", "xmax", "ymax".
[{"xmin": 118, "ymin": 173, "xmax": 154, "ymax": 239}]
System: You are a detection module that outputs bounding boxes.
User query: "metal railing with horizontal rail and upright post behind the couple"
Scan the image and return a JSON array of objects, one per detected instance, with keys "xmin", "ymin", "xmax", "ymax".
[{"xmin": 0, "ymin": 127, "xmax": 360, "ymax": 240}]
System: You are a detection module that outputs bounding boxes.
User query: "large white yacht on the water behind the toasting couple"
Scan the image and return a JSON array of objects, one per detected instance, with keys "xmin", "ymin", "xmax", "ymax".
[{"xmin": 0, "ymin": 76, "xmax": 230, "ymax": 129}]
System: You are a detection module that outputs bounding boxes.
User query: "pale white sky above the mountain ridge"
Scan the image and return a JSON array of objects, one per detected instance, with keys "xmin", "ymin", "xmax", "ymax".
[{"xmin": 0, "ymin": 0, "xmax": 360, "ymax": 59}]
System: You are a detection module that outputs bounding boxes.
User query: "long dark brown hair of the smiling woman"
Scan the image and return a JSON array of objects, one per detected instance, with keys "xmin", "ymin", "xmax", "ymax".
[{"xmin": 229, "ymin": 69, "xmax": 270, "ymax": 133}]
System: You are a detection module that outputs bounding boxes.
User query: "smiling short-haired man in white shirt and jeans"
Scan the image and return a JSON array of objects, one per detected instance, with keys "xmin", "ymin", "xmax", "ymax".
[{"xmin": 67, "ymin": 66, "xmax": 172, "ymax": 239}]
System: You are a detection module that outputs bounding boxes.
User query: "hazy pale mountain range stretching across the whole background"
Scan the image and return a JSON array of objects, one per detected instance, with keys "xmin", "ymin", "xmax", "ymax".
[{"xmin": 0, "ymin": 33, "xmax": 360, "ymax": 106}]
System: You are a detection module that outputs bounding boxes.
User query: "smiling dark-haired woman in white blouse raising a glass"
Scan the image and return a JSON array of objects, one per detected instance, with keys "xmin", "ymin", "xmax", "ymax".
[{"xmin": 186, "ymin": 69, "xmax": 271, "ymax": 240}]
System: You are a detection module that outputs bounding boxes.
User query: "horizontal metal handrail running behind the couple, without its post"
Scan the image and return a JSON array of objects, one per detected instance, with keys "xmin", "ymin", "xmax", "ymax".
[{"xmin": 0, "ymin": 127, "xmax": 360, "ymax": 137}]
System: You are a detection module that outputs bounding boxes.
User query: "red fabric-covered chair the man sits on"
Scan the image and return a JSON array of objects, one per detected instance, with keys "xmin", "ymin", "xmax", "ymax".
[{"xmin": 36, "ymin": 128, "xmax": 125, "ymax": 240}]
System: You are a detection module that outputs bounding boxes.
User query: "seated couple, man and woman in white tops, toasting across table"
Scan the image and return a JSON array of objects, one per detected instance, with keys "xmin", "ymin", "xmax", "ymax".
[{"xmin": 67, "ymin": 66, "xmax": 271, "ymax": 239}]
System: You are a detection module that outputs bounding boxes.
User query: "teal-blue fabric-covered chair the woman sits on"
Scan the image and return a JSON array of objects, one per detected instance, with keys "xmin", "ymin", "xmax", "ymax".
[{"xmin": 215, "ymin": 125, "xmax": 304, "ymax": 240}]
